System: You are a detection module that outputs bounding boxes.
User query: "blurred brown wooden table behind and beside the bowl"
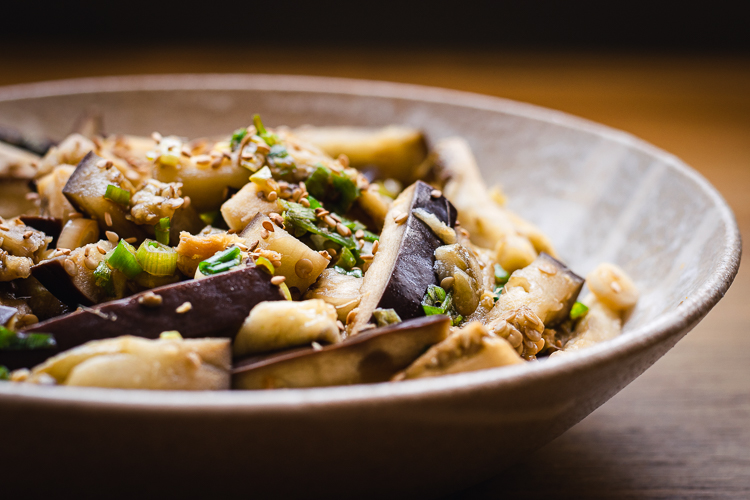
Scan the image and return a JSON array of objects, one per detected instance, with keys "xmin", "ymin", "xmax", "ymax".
[{"xmin": 0, "ymin": 46, "xmax": 750, "ymax": 499}]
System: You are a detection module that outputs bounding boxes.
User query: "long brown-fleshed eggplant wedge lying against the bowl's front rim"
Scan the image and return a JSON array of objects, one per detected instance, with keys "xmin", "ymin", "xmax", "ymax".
[{"xmin": 232, "ymin": 315, "xmax": 450, "ymax": 389}]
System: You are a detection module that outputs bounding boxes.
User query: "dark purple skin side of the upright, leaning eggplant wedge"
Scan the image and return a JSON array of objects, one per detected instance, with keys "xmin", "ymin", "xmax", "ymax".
[{"xmin": 378, "ymin": 181, "xmax": 457, "ymax": 319}]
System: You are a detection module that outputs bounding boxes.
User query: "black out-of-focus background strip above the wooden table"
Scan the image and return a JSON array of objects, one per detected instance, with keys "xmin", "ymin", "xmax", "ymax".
[{"xmin": 0, "ymin": 0, "xmax": 750, "ymax": 54}]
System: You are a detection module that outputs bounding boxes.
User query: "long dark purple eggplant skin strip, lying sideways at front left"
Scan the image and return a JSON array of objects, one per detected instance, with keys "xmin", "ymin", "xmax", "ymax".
[{"xmin": 23, "ymin": 266, "xmax": 285, "ymax": 351}]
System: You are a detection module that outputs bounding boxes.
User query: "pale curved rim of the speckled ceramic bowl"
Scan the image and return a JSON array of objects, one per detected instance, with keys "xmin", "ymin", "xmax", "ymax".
[{"xmin": 0, "ymin": 73, "xmax": 742, "ymax": 413}]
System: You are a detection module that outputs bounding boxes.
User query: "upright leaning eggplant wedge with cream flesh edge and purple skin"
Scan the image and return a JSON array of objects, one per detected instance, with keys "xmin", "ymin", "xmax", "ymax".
[{"xmin": 350, "ymin": 181, "xmax": 457, "ymax": 332}]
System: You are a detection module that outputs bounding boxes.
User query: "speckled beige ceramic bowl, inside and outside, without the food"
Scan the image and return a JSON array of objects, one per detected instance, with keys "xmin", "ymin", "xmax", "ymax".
[{"xmin": 0, "ymin": 75, "xmax": 741, "ymax": 498}]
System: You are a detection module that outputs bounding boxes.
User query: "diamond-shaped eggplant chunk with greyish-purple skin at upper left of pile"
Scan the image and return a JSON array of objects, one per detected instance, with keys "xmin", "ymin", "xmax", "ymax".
[{"xmin": 63, "ymin": 151, "xmax": 146, "ymax": 242}]
